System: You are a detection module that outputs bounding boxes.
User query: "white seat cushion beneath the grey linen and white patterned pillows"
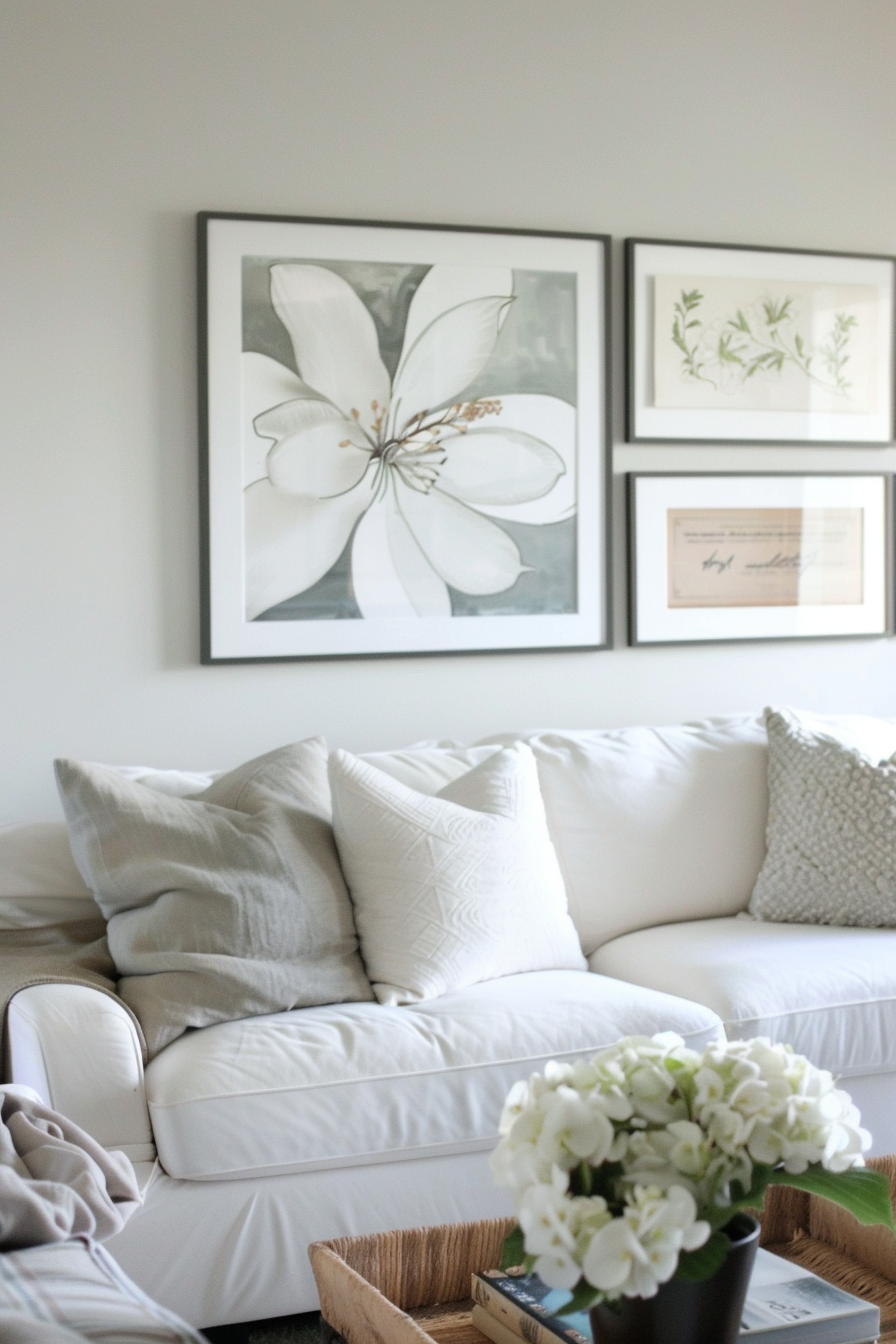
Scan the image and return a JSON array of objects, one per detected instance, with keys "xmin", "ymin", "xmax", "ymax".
[{"xmin": 146, "ymin": 970, "xmax": 720, "ymax": 1180}]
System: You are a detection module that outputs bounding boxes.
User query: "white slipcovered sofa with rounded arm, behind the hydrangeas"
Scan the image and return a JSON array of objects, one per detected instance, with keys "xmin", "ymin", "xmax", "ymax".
[{"xmin": 0, "ymin": 715, "xmax": 896, "ymax": 1325}]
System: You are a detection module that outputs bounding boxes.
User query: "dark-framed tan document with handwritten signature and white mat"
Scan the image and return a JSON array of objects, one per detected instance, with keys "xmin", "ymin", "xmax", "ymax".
[{"xmin": 627, "ymin": 473, "xmax": 891, "ymax": 644}]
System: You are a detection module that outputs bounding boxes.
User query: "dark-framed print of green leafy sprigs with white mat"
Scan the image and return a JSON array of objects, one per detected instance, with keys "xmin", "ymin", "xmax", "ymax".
[{"xmin": 626, "ymin": 238, "xmax": 896, "ymax": 444}]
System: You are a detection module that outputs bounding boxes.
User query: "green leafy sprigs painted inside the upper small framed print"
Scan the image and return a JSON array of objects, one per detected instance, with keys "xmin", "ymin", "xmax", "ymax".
[{"xmin": 670, "ymin": 289, "xmax": 858, "ymax": 399}]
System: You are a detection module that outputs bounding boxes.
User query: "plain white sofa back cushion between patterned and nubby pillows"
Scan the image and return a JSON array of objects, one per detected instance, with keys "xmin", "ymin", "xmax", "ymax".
[{"xmin": 483, "ymin": 715, "xmax": 767, "ymax": 956}]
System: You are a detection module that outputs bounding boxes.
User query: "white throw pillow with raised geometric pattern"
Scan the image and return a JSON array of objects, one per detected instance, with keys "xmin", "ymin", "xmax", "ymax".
[{"xmin": 330, "ymin": 743, "xmax": 587, "ymax": 1004}]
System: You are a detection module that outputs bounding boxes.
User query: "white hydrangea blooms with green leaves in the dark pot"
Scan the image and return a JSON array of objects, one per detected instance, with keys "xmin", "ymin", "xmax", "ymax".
[{"xmin": 492, "ymin": 1032, "xmax": 896, "ymax": 1310}]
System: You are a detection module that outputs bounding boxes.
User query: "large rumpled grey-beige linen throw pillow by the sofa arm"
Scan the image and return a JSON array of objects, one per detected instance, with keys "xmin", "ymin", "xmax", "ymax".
[{"xmin": 56, "ymin": 738, "xmax": 373, "ymax": 1055}]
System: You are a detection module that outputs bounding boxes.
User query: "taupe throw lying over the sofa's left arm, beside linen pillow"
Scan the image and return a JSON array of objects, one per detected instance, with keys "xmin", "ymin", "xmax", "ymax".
[{"xmin": 0, "ymin": 918, "xmax": 146, "ymax": 1083}]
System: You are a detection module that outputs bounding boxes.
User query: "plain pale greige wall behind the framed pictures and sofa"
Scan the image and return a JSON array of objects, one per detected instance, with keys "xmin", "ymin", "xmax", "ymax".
[{"xmin": 0, "ymin": 0, "xmax": 896, "ymax": 818}]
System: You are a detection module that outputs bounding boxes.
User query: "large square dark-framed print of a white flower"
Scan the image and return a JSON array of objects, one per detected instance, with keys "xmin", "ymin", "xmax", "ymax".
[{"xmin": 199, "ymin": 212, "xmax": 610, "ymax": 663}]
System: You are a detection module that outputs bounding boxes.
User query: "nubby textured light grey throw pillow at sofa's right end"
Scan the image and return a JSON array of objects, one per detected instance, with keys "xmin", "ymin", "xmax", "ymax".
[{"xmin": 750, "ymin": 710, "xmax": 896, "ymax": 927}]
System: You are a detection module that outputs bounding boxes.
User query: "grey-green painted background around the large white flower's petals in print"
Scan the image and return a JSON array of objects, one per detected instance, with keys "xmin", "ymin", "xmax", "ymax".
[{"xmin": 243, "ymin": 257, "xmax": 576, "ymax": 621}]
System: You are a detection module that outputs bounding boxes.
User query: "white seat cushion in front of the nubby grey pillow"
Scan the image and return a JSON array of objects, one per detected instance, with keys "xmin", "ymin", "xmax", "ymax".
[{"xmin": 588, "ymin": 917, "xmax": 896, "ymax": 1078}]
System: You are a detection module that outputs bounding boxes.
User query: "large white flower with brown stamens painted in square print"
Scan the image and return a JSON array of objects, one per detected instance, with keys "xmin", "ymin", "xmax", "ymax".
[{"xmin": 242, "ymin": 261, "xmax": 578, "ymax": 621}]
